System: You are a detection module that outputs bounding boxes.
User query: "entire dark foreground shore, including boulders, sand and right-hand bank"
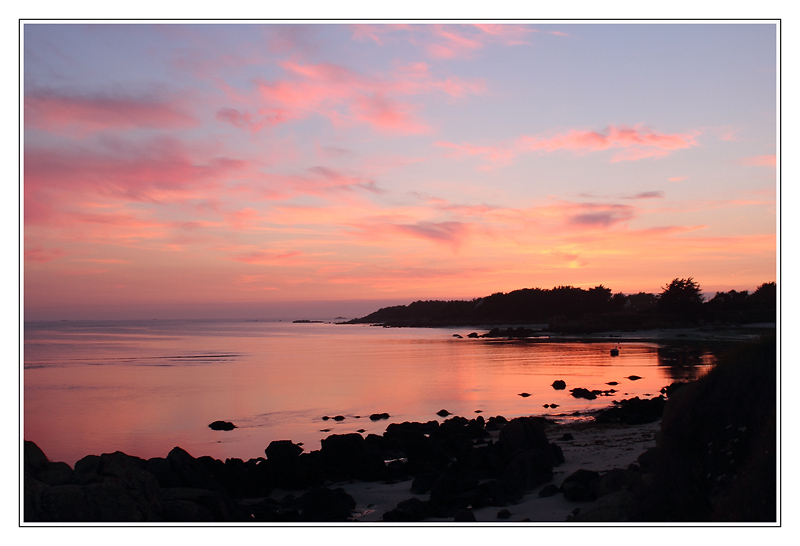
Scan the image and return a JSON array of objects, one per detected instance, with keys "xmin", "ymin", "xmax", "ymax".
[{"xmin": 23, "ymin": 338, "xmax": 777, "ymax": 524}]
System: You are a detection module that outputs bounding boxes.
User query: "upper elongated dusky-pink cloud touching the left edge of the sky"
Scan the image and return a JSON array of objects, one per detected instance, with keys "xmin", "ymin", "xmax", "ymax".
[{"xmin": 25, "ymin": 92, "xmax": 197, "ymax": 134}]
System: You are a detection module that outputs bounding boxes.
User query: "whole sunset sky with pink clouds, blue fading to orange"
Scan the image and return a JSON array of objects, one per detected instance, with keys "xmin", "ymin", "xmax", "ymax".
[{"xmin": 22, "ymin": 21, "xmax": 779, "ymax": 320}]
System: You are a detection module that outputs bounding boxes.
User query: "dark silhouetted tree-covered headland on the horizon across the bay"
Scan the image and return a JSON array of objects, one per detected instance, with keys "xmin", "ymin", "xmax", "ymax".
[{"xmin": 349, "ymin": 277, "xmax": 777, "ymax": 332}]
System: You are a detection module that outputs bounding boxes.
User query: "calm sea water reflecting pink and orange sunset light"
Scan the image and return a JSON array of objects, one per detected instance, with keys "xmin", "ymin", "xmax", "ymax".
[{"xmin": 22, "ymin": 320, "xmax": 715, "ymax": 465}]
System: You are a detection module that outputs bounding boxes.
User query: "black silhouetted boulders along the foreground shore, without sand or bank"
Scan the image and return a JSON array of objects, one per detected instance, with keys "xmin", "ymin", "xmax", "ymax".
[{"xmin": 24, "ymin": 388, "xmax": 676, "ymax": 523}]
